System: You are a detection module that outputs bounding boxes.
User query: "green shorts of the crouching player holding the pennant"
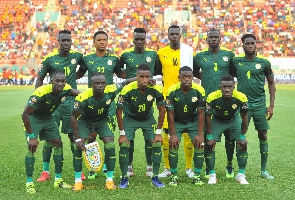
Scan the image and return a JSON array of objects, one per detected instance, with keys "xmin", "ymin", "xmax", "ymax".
[{"xmin": 78, "ymin": 117, "xmax": 115, "ymax": 139}]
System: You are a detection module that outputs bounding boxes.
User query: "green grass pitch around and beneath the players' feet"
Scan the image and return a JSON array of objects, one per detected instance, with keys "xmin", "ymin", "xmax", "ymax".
[{"xmin": 0, "ymin": 85, "xmax": 295, "ymax": 200}]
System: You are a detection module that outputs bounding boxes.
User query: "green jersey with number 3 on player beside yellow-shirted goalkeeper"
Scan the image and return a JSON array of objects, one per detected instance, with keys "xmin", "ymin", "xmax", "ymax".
[{"xmin": 194, "ymin": 47, "xmax": 235, "ymax": 95}]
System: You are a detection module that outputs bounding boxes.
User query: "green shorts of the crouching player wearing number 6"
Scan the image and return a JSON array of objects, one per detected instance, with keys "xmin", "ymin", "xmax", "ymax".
[{"xmin": 168, "ymin": 121, "xmax": 198, "ymax": 141}]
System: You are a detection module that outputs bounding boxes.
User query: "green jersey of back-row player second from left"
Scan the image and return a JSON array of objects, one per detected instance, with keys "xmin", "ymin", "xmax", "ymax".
[{"xmin": 79, "ymin": 53, "xmax": 122, "ymax": 88}]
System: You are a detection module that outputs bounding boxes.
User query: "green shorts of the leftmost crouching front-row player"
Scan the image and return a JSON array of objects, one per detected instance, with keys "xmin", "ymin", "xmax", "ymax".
[{"xmin": 25, "ymin": 116, "xmax": 60, "ymax": 140}]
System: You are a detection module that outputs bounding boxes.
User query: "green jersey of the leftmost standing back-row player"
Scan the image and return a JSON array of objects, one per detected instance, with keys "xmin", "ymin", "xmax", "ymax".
[{"xmin": 38, "ymin": 50, "xmax": 84, "ymax": 89}]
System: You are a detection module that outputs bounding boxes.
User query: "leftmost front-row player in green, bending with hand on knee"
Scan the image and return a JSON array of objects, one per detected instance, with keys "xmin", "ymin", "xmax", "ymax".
[{"xmin": 22, "ymin": 71, "xmax": 79, "ymax": 194}]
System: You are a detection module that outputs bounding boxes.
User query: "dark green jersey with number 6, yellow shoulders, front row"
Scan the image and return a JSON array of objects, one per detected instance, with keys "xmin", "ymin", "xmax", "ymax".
[{"xmin": 166, "ymin": 82, "xmax": 206, "ymax": 123}]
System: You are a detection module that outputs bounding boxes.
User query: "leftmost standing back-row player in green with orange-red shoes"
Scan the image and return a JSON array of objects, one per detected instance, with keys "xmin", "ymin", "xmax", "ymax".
[{"xmin": 35, "ymin": 30, "xmax": 85, "ymax": 182}]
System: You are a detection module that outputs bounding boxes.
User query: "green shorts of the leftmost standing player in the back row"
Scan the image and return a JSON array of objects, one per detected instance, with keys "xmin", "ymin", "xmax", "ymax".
[{"xmin": 53, "ymin": 97, "xmax": 75, "ymax": 134}]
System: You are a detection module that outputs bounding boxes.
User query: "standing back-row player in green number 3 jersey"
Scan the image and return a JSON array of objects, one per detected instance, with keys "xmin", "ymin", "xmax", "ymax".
[{"xmin": 194, "ymin": 28, "xmax": 235, "ymax": 178}]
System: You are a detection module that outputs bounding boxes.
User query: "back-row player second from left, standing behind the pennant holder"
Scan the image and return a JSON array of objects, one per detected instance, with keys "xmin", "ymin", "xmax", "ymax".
[{"xmin": 77, "ymin": 31, "xmax": 125, "ymax": 179}]
